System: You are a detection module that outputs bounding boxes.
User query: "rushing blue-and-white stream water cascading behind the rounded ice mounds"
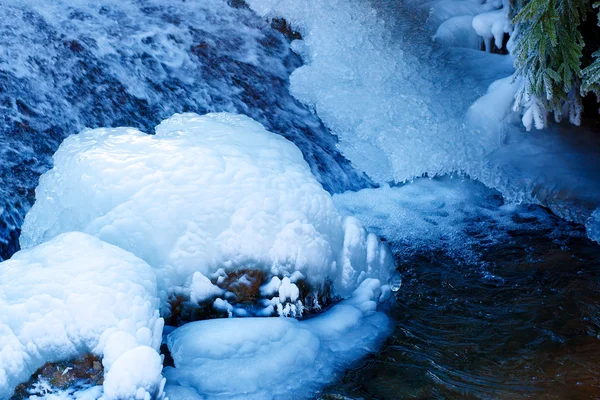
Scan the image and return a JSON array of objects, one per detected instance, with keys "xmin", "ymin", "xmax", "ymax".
[{"xmin": 0, "ymin": 0, "xmax": 369, "ymax": 258}]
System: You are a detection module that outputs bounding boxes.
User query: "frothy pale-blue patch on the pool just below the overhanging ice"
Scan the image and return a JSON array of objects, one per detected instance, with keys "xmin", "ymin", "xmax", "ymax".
[{"xmin": 333, "ymin": 176, "xmax": 568, "ymax": 263}]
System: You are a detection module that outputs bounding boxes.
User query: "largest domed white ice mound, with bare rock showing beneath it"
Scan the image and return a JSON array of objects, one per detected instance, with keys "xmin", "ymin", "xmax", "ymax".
[{"xmin": 20, "ymin": 113, "xmax": 393, "ymax": 300}]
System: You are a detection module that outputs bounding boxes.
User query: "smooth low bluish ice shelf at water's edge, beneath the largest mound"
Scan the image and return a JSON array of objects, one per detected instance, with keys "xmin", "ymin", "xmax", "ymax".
[{"xmin": 165, "ymin": 279, "xmax": 391, "ymax": 399}]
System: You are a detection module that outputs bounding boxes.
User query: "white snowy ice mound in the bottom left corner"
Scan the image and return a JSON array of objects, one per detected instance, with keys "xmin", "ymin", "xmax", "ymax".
[{"xmin": 0, "ymin": 232, "xmax": 164, "ymax": 400}]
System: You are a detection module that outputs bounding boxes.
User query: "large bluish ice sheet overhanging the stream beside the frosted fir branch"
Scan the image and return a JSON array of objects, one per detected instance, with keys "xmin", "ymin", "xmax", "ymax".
[{"xmin": 248, "ymin": 0, "xmax": 600, "ymax": 239}]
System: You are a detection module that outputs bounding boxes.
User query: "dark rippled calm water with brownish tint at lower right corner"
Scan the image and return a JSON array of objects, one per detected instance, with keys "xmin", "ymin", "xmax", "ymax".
[{"xmin": 327, "ymin": 212, "xmax": 600, "ymax": 399}]
